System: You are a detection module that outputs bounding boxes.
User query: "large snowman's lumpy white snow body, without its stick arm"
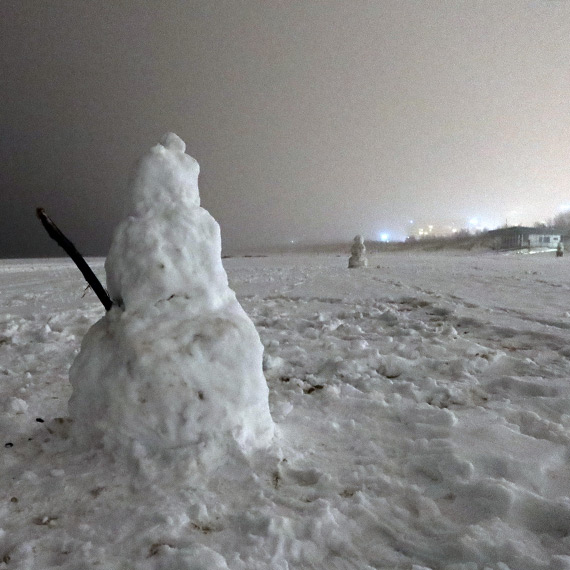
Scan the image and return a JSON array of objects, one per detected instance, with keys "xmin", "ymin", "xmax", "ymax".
[{"xmin": 69, "ymin": 133, "xmax": 274, "ymax": 457}]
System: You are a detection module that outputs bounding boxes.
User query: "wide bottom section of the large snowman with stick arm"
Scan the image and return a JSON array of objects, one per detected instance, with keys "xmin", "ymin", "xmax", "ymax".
[{"xmin": 69, "ymin": 299, "xmax": 273, "ymax": 457}]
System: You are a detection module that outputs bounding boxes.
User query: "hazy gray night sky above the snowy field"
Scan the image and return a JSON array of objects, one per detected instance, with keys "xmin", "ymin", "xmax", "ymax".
[{"xmin": 0, "ymin": 0, "xmax": 570, "ymax": 253}]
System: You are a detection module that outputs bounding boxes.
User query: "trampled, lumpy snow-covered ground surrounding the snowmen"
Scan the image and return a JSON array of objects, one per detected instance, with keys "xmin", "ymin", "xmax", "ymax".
[{"xmin": 0, "ymin": 253, "xmax": 570, "ymax": 570}]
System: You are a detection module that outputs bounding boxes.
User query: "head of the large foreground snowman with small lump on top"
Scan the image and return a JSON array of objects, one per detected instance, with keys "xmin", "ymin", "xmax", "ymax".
[{"xmin": 131, "ymin": 133, "xmax": 200, "ymax": 215}]
